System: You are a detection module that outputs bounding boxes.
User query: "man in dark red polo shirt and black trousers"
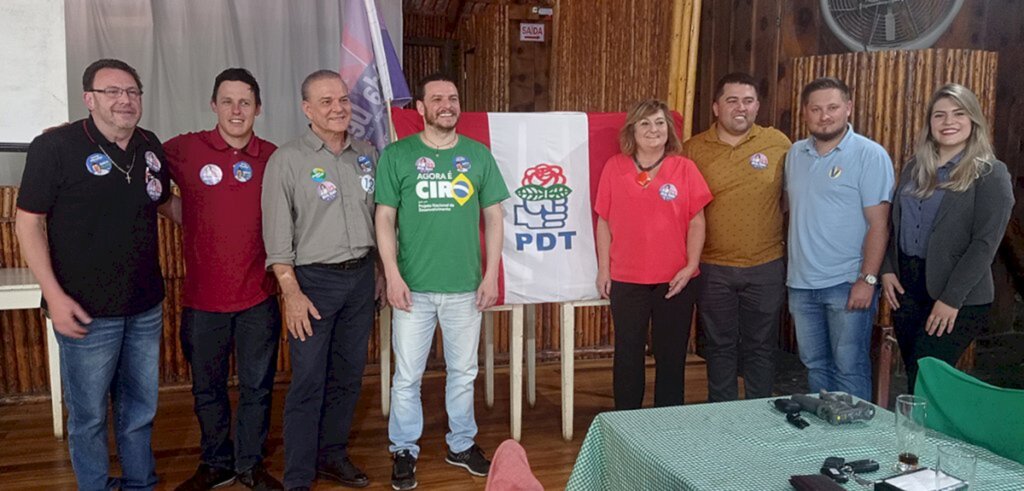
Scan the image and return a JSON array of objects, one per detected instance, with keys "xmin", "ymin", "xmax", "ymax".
[{"xmin": 162, "ymin": 69, "xmax": 283, "ymax": 490}]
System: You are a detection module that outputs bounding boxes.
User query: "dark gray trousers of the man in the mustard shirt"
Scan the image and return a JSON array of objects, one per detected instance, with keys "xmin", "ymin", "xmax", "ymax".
[{"xmin": 697, "ymin": 258, "xmax": 785, "ymax": 402}]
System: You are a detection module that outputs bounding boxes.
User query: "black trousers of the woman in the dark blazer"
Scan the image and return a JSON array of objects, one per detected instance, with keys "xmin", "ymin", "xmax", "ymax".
[{"xmin": 893, "ymin": 252, "xmax": 992, "ymax": 394}]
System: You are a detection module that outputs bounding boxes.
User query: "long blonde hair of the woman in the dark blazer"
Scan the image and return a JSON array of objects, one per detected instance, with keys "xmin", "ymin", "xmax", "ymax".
[{"xmin": 910, "ymin": 84, "xmax": 995, "ymax": 199}]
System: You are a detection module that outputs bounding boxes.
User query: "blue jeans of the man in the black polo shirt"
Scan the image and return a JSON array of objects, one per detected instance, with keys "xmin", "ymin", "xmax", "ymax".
[{"xmin": 56, "ymin": 303, "xmax": 164, "ymax": 490}]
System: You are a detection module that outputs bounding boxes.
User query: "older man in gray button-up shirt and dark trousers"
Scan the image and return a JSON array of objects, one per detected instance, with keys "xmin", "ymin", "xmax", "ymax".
[{"xmin": 262, "ymin": 70, "xmax": 379, "ymax": 488}]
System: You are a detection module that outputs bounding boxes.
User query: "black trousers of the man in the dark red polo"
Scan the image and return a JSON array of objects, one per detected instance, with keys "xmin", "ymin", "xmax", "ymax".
[{"xmin": 180, "ymin": 296, "xmax": 281, "ymax": 472}]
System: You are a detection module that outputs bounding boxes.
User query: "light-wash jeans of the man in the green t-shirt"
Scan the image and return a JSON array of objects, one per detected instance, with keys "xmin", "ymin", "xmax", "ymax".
[{"xmin": 388, "ymin": 292, "xmax": 480, "ymax": 456}]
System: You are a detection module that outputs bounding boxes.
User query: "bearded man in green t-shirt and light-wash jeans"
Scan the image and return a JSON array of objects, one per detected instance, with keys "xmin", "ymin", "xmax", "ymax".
[{"xmin": 375, "ymin": 75, "xmax": 509, "ymax": 490}]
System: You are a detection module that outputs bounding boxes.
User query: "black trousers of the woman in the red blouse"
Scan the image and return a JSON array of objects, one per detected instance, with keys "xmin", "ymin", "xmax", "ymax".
[{"xmin": 609, "ymin": 280, "xmax": 696, "ymax": 410}]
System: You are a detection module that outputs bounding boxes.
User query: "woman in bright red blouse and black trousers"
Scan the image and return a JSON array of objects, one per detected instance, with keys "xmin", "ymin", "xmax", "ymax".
[{"xmin": 594, "ymin": 99, "xmax": 712, "ymax": 409}]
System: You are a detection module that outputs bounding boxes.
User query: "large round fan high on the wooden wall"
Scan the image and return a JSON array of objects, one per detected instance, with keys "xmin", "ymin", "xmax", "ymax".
[{"xmin": 821, "ymin": 0, "xmax": 964, "ymax": 51}]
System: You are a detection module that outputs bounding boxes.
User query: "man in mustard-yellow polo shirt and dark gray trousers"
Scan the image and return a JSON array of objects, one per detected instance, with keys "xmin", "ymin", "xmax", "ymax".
[{"xmin": 683, "ymin": 73, "xmax": 792, "ymax": 402}]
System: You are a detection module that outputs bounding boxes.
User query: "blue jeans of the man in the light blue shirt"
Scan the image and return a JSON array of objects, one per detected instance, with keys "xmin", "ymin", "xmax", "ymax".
[{"xmin": 790, "ymin": 283, "xmax": 879, "ymax": 401}]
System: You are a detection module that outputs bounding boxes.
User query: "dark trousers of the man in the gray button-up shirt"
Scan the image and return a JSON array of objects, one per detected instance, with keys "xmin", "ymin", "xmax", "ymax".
[{"xmin": 284, "ymin": 260, "xmax": 375, "ymax": 488}]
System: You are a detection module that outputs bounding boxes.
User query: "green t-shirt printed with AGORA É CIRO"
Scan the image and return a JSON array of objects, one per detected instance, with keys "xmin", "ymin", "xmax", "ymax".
[{"xmin": 375, "ymin": 133, "xmax": 509, "ymax": 293}]
